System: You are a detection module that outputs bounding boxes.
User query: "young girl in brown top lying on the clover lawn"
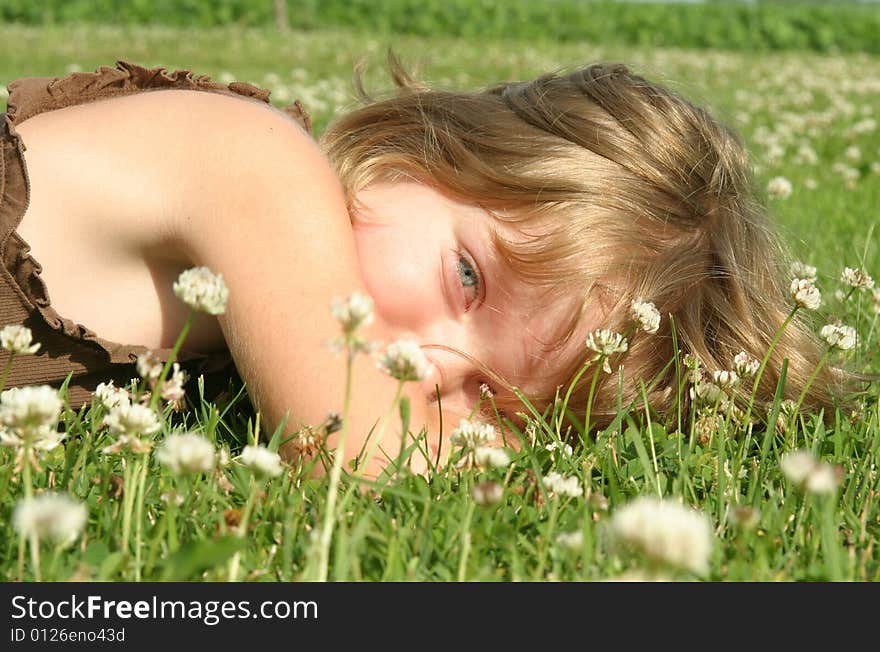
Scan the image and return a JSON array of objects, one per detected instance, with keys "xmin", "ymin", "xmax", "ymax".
[{"xmin": 0, "ymin": 62, "xmax": 840, "ymax": 468}]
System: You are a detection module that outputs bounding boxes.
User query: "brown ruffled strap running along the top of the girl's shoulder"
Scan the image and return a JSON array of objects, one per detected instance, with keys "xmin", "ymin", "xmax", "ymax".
[{"xmin": 6, "ymin": 61, "xmax": 311, "ymax": 133}]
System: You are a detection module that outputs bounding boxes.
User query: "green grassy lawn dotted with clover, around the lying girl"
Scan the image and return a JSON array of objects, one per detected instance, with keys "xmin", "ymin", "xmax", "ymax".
[{"xmin": 0, "ymin": 26, "xmax": 880, "ymax": 581}]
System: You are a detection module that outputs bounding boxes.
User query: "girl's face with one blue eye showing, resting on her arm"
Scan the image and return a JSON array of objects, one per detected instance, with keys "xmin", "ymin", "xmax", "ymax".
[{"xmin": 352, "ymin": 181, "xmax": 590, "ymax": 428}]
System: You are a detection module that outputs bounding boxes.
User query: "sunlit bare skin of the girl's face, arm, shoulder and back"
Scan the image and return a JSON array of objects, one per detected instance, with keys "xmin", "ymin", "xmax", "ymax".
[{"xmin": 18, "ymin": 91, "xmax": 594, "ymax": 474}]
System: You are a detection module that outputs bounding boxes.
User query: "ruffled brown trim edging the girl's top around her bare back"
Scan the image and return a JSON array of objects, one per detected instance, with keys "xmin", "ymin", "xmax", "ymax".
[{"xmin": 0, "ymin": 61, "xmax": 311, "ymax": 373}]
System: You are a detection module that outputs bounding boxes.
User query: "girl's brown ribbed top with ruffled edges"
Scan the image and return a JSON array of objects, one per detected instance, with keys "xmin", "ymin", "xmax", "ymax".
[{"xmin": 0, "ymin": 61, "xmax": 311, "ymax": 408}]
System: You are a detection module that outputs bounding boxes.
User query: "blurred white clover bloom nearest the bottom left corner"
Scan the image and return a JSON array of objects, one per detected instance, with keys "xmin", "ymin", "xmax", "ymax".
[{"xmin": 12, "ymin": 493, "xmax": 88, "ymax": 546}]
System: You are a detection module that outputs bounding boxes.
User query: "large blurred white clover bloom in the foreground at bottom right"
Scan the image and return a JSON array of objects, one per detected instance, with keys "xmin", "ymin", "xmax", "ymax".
[{"xmin": 610, "ymin": 496, "xmax": 712, "ymax": 575}]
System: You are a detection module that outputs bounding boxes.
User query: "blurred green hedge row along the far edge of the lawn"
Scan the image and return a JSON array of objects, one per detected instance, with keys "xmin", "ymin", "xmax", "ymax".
[{"xmin": 0, "ymin": 0, "xmax": 880, "ymax": 52}]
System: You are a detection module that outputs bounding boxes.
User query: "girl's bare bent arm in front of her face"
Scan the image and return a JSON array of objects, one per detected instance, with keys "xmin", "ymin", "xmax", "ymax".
[{"xmin": 182, "ymin": 93, "xmax": 439, "ymax": 473}]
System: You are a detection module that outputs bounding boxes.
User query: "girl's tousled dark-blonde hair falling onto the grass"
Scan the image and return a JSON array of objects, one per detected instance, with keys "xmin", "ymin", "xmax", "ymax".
[{"xmin": 321, "ymin": 55, "xmax": 844, "ymax": 426}]
